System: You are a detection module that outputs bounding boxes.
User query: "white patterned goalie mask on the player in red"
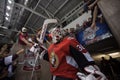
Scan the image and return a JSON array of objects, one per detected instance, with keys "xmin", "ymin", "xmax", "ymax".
[{"xmin": 51, "ymin": 28, "xmax": 65, "ymax": 43}]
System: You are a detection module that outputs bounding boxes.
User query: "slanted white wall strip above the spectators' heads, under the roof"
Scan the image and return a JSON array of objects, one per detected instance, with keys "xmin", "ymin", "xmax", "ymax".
[{"xmin": 64, "ymin": 11, "xmax": 91, "ymax": 29}]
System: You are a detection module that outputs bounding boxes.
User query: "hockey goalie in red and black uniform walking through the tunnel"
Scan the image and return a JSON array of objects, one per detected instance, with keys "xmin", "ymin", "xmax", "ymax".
[{"xmin": 30, "ymin": 19, "xmax": 107, "ymax": 80}]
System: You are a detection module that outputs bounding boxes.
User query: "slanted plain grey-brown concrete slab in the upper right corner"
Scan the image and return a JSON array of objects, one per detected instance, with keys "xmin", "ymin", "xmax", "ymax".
[{"xmin": 98, "ymin": 0, "xmax": 120, "ymax": 47}]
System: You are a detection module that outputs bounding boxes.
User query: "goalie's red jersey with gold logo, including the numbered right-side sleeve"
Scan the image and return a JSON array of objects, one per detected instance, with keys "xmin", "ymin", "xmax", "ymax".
[{"xmin": 48, "ymin": 37, "xmax": 94, "ymax": 80}]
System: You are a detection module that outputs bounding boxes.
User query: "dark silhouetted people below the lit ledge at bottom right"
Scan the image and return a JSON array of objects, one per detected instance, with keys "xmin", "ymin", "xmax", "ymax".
[{"xmin": 100, "ymin": 56, "xmax": 120, "ymax": 80}]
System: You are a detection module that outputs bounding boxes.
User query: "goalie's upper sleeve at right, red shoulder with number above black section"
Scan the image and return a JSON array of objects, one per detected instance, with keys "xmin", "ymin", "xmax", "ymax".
[{"xmin": 69, "ymin": 38, "xmax": 88, "ymax": 68}]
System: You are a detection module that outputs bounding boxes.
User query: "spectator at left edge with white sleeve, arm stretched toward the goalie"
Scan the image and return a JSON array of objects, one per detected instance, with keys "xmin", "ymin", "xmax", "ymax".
[{"xmin": 0, "ymin": 45, "xmax": 23, "ymax": 80}]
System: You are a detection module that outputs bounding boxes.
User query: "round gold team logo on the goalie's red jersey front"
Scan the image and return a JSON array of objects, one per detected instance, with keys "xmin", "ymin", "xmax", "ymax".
[{"xmin": 50, "ymin": 52, "xmax": 59, "ymax": 68}]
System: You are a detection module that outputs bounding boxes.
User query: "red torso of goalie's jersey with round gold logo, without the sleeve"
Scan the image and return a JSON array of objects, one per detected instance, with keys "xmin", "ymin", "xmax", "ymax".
[{"xmin": 48, "ymin": 37, "xmax": 79, "ymax": 79}]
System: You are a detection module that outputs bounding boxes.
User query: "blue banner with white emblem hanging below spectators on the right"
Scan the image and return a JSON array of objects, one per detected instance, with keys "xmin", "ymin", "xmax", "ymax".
[{"xmin": 76, "ymin": 22, "xmax": 112, "ymax": 45}]
